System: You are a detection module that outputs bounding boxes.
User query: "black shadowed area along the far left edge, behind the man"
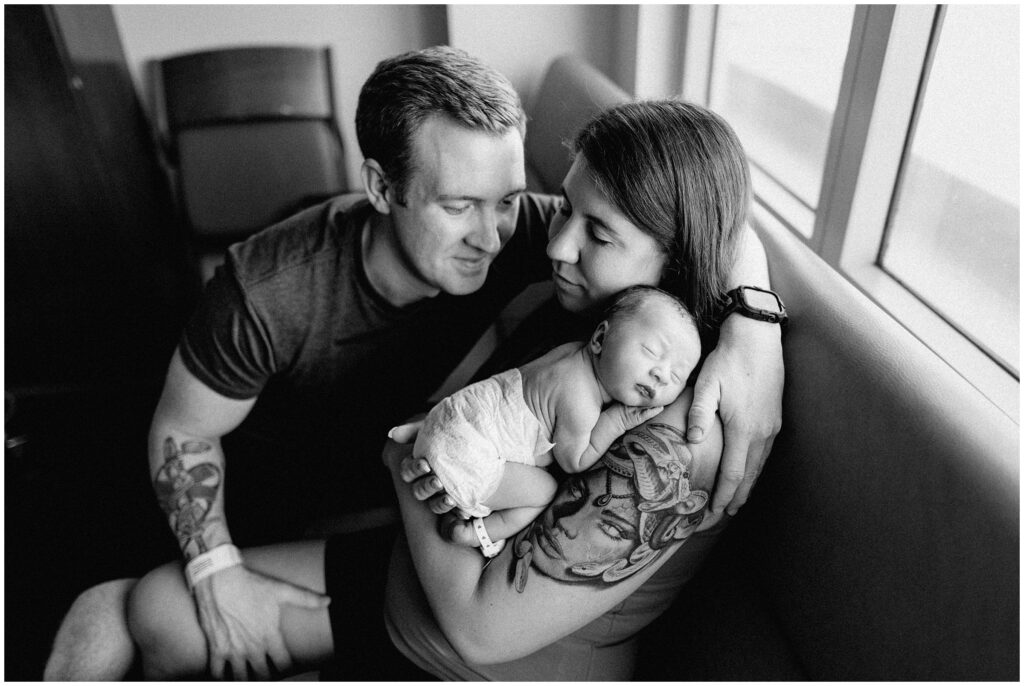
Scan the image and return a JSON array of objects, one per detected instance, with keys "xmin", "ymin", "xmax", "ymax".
[{"xmin": 3, "ymin": 5, "xmax": 198, "ymax": 681}]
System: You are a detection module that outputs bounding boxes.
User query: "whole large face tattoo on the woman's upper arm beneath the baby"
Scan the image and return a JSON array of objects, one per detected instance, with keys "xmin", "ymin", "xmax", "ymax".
[{"xmin": 511, "ymin": 422, "xmax": 708, "ymax": 593}]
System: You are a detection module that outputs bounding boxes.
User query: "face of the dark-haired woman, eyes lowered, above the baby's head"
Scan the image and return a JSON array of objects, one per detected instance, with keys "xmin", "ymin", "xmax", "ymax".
[{"xmin": 548, "ymin": 156, "xmax": 667, "ymax": 312}]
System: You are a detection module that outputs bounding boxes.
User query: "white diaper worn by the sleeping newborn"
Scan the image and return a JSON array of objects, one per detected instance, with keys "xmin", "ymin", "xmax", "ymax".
[{"xmin": 413, "ymin": 369, "xmax": 554, "ymax": 517}]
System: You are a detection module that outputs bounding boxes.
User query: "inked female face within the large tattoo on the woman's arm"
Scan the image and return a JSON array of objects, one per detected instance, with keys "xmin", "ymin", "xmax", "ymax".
[{"xmin": 529, "ymin": 468, "xmax": 640, "ymax": 582}]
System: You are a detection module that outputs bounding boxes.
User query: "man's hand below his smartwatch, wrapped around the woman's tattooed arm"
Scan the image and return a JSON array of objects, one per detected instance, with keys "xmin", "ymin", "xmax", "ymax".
[{"xmin": 686, "ymin": 314, "xmax": 785, "ymax": 515}]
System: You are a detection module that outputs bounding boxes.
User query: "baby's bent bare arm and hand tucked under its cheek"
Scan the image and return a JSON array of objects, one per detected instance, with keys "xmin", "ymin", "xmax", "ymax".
[{"xmin": 551, "ymin": 402, "xmax": 663, "ymax": 474}]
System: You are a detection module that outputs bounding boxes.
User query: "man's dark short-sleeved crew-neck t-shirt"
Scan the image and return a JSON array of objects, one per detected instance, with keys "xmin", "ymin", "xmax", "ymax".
[{"xmin": 179, "ymin": 196, "xmax": 556, "ymax": 522}]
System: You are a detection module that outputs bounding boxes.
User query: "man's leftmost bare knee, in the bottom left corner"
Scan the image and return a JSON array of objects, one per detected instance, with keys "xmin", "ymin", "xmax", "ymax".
[{"xmin": 43, "ymin": 578, "xmax": 138, "ymax": 681}]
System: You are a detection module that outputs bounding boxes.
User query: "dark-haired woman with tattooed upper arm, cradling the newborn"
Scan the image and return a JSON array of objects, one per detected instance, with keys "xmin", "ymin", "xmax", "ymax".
[{"xmin": 372, "ymin": 100, "xmax": 749, "ymax": 680}]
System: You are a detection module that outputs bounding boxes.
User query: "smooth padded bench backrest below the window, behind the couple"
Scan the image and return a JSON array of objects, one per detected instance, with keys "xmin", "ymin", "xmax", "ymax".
[{"xmin": 526, "ymin": 51, "xmax": 1020, "ymax": 680}]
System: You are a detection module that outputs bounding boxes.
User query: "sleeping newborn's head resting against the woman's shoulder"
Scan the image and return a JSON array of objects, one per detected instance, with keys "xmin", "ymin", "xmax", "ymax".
[{"xmin": 588, "ymin": 286, "xmax": 700, "ymax": 406}]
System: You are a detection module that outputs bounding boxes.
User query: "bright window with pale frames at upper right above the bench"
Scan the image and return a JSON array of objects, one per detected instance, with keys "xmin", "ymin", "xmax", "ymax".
[{"xmin": 684, "ymin": 5, "xmax": 1020, "ymax": 416}]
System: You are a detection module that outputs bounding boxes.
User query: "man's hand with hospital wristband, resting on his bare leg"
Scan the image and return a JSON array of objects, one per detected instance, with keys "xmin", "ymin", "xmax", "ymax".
[{"xmin": 196, "ymin": 565, "xmax": 331, "ymax": 680}]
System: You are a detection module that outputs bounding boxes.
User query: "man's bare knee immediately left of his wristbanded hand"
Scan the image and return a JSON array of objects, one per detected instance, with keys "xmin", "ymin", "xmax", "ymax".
[{"xmin": 128, "ymin": 563, "xmax": 206, "ymax": 679}]
